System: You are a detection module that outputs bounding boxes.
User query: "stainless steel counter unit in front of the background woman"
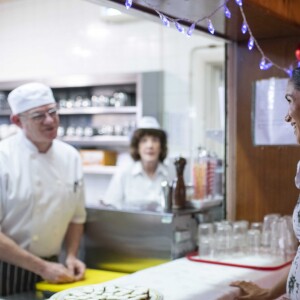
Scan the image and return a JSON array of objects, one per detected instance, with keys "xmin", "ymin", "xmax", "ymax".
[{"xmin": 84, "ymin": 208, "xmax": 221, "ymax": 273}]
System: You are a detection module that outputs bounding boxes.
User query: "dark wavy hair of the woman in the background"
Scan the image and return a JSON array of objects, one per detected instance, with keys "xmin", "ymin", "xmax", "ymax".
[{"xmin": 130, "ymin": 128, "xmax": 168, "ymax": 162}]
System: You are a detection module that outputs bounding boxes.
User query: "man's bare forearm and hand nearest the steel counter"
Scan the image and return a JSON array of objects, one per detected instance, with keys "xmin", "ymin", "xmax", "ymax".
[{"xmin": 65, "ymin": 223, "xmax": 85, "ymax": 280}]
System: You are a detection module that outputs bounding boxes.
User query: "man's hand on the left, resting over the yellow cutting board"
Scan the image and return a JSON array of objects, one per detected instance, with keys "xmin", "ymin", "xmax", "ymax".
[{"xmin": 40, "ymin": 262, "xmax": 75, "ymax": 283}]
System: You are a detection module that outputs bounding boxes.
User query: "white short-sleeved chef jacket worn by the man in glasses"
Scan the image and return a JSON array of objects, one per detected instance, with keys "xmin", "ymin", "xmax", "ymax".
[{"xmin": 0, "ymin": 132, "xmax": 86, "ymax": 257}]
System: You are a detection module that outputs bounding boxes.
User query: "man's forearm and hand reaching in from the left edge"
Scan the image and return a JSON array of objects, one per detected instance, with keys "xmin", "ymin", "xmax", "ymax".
[{"xmin": 0, "ymin": 232, "xmax": 74, "ymax": 283}]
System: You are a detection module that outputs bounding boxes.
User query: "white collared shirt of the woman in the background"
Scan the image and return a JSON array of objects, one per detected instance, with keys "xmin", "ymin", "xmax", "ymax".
[{"xmin": 104, "ymin": 161, "xmax": 168, "ymax": 210}]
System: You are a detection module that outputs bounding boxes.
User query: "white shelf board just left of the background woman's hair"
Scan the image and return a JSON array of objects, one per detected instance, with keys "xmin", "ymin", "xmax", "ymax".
[{"xmin": 60, "ymin": 135, "xmax": 129, "ymax": 147}]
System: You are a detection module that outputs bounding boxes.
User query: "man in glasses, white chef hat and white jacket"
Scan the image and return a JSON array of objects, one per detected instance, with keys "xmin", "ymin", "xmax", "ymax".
[{"xmin": 0, "ymin": 82, "xmax": 86, "ymax": 296}]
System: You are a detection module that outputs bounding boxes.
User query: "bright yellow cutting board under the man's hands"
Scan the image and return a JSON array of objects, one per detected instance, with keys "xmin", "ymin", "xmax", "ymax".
[{"xmin": 35, "ymin": 269, "xmax": 128, "ymax": 293}]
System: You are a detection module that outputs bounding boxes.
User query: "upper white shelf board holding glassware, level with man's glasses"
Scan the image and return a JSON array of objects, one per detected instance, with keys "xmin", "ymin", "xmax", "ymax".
[{"xmin": 59, "ymin": 106, "xmax": 137, "ymax": 115}]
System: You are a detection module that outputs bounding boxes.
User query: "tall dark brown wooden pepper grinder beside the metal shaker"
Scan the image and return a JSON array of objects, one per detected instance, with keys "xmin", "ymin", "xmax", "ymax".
[{"xmin": 172, "ymin": 157, "xmax": 186, "ymax": 209}]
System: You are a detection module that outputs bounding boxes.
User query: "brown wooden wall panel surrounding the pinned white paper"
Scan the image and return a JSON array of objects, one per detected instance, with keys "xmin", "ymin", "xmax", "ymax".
[{"xmin": 234, "ymin": 38, "xmax": 300, "ymax": 221}]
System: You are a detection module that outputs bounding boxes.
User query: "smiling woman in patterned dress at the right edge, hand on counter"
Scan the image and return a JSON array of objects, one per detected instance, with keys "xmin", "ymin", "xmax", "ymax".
[{"xmin": 231, "ymin": 68, "xmax": 300, "ymax": 300}]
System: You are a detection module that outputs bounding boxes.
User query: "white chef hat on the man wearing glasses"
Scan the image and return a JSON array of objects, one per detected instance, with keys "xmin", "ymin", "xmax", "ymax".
[{"xmin": 7, "ymin": 82, "xmax": 55, "ymax": 115}]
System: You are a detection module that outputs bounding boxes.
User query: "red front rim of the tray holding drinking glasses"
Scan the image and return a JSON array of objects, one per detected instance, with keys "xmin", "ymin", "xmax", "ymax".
[{"xmin": 186, "ymin": 252, "xmax": 293, "ymax": 271}]
